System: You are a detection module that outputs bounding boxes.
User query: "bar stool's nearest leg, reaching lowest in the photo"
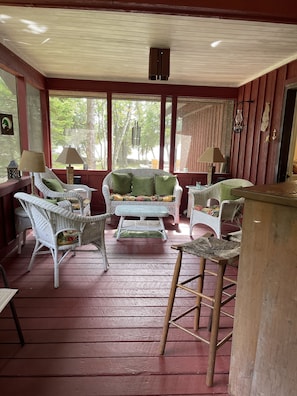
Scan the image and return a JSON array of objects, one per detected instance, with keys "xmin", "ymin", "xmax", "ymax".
[{"xmin": 206, "ymin": 261, "xmax": 227, "ymax": 386}]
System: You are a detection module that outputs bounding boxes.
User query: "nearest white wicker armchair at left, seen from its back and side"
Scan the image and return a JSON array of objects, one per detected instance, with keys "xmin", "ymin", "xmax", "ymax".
[{"xmin": 14, "ymin": 192, "xmax": 110, "ymax": 288}]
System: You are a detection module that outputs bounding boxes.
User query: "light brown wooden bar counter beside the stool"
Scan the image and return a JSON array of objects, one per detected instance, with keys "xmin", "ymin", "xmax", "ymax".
[{"xmin": 229, "ymin": 182, "xmax": 297, "ymax": 396}]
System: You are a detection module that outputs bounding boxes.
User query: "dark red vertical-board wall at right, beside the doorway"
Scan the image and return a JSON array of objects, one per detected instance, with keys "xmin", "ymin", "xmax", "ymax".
[{"xmin": 231, "ymin": 61, "xmax": 297, "ymax": 184}]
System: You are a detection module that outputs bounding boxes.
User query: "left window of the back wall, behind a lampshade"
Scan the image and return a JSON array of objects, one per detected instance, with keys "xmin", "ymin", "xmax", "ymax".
[{"xmin": 50, "ymin": 95, "xmax": 107, "ymax": 170}]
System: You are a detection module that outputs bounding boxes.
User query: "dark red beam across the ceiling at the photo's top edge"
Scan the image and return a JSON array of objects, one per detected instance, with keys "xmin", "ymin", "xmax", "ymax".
[{"xmin": 1, "ymin": 0, "xmax": 297, "ymax": 24}]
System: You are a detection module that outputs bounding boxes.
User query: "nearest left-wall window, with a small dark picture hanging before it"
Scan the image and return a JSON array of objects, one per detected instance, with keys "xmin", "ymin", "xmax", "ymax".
[{"xmin": 0, "ymin": 69, "xmax": 20, "ymax": 183}]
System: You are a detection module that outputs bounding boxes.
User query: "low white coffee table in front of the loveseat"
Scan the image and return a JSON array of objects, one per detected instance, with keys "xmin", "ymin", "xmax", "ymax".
[{"xmin": 115, "ymin": 205, "xmax": 169, "ymax": 241}]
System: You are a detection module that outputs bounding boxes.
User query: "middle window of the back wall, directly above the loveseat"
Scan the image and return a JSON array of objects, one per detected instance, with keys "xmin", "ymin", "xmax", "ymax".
[{"xmin": 112, "ymin": 95, "xmax": 160, "ymax": 169}]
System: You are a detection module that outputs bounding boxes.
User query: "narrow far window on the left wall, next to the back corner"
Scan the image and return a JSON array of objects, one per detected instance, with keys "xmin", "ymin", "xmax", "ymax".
[{"xmin": 26, "ymin": 84, "xmax": 43, "ymax": 152}]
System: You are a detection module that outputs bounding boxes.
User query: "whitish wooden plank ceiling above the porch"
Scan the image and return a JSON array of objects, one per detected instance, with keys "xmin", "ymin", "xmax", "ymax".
[{"xmin": 0, "ymin": 2, "xmax": 297, "ymax": 87}]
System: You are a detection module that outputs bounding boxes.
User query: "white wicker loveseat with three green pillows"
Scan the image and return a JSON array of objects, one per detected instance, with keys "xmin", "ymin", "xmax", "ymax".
[{"xmin": 102, "ymin": 168, "xmax": 183, "ymax": 224}]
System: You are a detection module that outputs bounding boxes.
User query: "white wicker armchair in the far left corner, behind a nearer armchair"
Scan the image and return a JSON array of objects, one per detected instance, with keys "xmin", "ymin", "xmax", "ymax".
[{"xmin": 34, "ymin": 167, "xmax": 94, "ymax": 216}]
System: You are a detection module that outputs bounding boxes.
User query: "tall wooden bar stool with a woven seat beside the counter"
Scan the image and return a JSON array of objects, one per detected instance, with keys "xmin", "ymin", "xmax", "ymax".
[{"xmin": 160, "ymin": 236, "xmax": 240, "ymax": 386}]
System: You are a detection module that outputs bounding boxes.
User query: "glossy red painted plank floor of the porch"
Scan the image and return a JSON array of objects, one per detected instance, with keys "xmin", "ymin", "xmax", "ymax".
[{"xmin": 0, "ymin": 218, "xmax": 236, "ymax": 396}]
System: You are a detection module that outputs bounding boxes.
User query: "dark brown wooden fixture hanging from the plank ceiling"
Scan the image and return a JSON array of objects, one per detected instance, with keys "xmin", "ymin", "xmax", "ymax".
[{"xmin": 149, "ymin": 48, "xmax": 170, "ymax": 80}]
